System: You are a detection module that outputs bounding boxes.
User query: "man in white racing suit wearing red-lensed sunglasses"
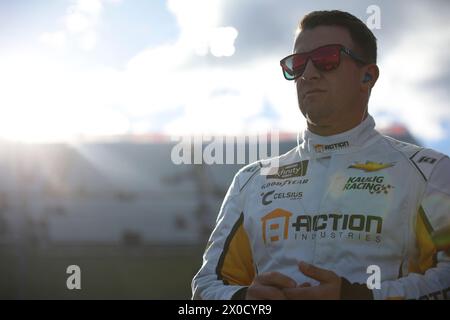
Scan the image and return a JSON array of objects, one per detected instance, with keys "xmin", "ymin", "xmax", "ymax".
[{"xmin": 192, "ymin": 11, "xmax": 450, "ymax": 299}]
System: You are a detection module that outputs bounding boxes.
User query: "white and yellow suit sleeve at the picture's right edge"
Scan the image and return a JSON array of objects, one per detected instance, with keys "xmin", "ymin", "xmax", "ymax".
[{"xmin": 373, "ymin": 157, "xmax": 450, "ymax": 299}]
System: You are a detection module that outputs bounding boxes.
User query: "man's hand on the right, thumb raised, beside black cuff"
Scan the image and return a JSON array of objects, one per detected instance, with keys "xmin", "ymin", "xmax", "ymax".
[{"xmin": 283, "ymin": 262, "xmax": 341, "ymax": 300}]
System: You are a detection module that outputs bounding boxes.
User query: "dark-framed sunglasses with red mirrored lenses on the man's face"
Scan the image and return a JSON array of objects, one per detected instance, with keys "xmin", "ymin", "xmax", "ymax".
[{"xmin": 280, "ymin": 44, "xmax": 367, "ymax": 80}]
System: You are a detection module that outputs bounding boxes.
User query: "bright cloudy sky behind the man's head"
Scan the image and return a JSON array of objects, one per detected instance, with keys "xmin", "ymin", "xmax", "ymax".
[{"xmin": 0, "ymin": 0, "xmax": 450, "ymax": 154}]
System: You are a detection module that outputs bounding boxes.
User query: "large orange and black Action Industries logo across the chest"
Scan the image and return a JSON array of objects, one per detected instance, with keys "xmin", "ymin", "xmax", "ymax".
[{"xmin": 261, "ymin": 208, "xmax": 383, "ymax": 244}]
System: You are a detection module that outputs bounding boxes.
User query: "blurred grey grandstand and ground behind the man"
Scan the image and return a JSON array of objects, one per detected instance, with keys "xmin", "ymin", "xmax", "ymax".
[{"xmin": 0, "ymin": 125, "xmax": 418, "ymax": 299}]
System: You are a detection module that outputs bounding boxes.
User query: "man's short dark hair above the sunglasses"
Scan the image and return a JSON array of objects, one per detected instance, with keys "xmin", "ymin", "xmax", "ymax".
[{"xmin": 300, "ymin": 10, "xmax": 377, "ymax": 63}]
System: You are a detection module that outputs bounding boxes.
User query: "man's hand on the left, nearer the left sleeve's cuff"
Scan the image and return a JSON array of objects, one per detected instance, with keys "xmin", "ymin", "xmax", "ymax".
[{"xmin": 245, "ymin": 272, "xmax": 297, "ymax": 300}]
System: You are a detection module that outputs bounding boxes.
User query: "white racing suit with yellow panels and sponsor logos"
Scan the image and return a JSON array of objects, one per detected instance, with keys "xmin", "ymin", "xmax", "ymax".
[{"xmin": 192, "ymin": 116, "xmax": 450, "ymax": 299}]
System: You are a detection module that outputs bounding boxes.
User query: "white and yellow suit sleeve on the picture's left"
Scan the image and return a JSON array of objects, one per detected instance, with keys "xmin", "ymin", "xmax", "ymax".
[{"xmin": 192, "ymin": 171, "xmax": 255, "ymax": 300}]
